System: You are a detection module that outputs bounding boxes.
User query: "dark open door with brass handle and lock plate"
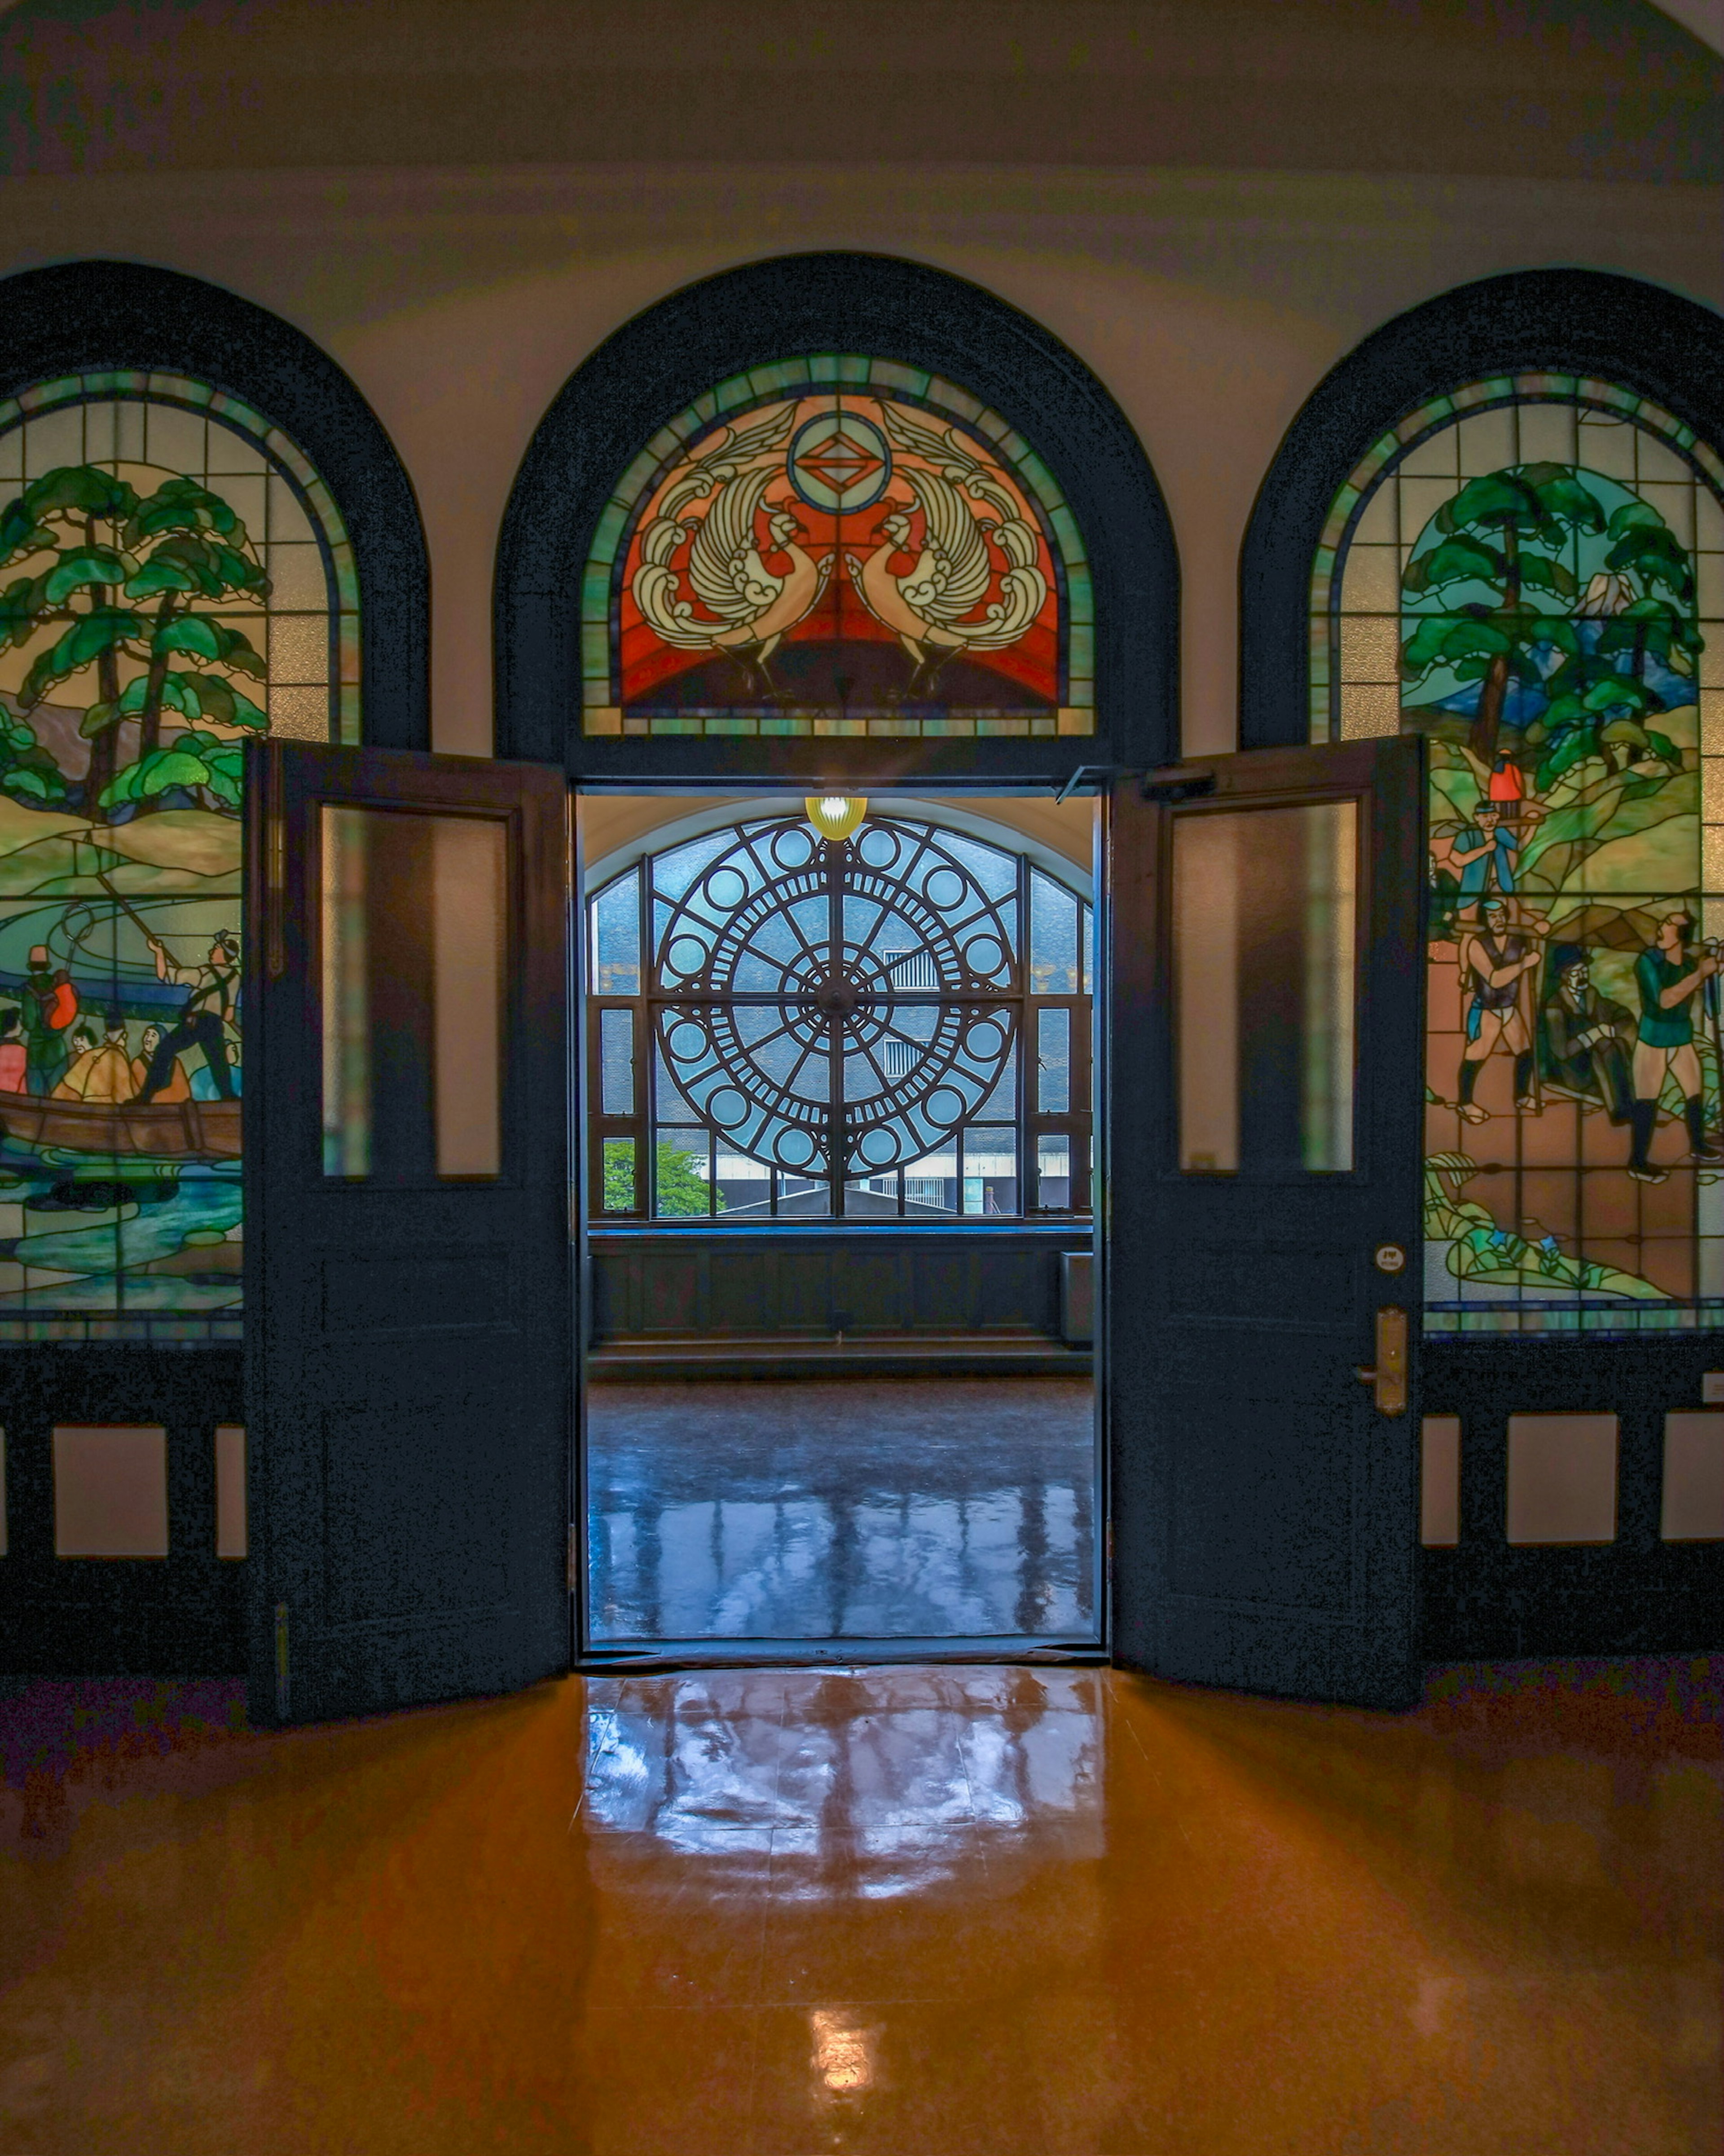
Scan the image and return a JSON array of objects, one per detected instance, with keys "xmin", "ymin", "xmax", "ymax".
[{"xmin": 1105, "ymin": 737, "xmax": 1425, "ymax": 1707}]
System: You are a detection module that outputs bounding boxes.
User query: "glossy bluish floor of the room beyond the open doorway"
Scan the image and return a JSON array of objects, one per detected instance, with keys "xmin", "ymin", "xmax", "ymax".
[{"xmin": 586, "ymin": 1378, "xmax": 1095, "ymax": 1641}]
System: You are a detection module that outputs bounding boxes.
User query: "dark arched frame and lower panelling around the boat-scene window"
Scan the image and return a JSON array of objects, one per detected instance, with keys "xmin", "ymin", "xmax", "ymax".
[{"xmin": 0, "ymin": 259, "xmax": 431, "ymax": 1677}]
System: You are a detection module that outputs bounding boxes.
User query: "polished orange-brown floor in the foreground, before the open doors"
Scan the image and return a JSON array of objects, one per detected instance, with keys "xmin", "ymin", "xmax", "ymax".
[{"xmin": 0, "ymin": 1658, "xmax": 1724, "ymax": 2156}]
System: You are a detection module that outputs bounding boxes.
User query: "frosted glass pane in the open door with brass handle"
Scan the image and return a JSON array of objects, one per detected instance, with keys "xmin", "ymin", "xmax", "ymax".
[{"xmin": 1172, "ymin": 802, "xmax": 1358, "ymax": 1175}]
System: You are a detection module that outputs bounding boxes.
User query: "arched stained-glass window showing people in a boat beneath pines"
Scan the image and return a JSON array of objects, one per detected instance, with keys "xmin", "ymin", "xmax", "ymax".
[{"xmin": 0, "ymin": 371, "xmax": 360, "ymax": 1341}]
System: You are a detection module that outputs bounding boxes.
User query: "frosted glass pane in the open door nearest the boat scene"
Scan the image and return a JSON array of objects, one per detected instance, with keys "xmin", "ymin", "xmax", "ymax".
[{"xmin": 323, "ymin": 807, "xmax": 509, "ymax": 1182}]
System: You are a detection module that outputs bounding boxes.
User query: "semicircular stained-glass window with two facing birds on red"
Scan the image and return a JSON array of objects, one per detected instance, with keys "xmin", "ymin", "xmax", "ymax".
[{"xmin": 582, "ymin": 353, "xmax": 1095, "ymax": 735}]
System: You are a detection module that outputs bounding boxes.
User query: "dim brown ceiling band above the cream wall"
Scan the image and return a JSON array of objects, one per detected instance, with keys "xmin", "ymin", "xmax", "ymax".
[{"xmin": 0, "ymin": 0, "xmax": 1724, "ymax": 181}]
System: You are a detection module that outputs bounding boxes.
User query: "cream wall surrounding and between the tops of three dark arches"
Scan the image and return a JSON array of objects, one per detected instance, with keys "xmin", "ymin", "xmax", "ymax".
[{"xmin": 0, "ymin": 166, "xmax": 1724, "ymax": 753}]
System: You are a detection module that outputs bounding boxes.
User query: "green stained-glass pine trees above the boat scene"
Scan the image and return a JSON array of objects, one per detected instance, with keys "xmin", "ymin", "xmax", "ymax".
[{"xmin": 0, "ymin": 463, "xmax": 269, "ymax": 824}]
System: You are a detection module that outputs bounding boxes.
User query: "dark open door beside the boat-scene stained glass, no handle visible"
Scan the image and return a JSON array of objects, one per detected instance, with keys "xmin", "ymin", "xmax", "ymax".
[{"xmin": 243, "ymin": 744, "xmax": 573, "ymax": 1723}]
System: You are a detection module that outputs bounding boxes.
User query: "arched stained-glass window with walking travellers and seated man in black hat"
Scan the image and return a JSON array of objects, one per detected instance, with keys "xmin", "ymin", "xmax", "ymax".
[{"xmin": 1310, "ymin": 373, "xmax": 1724, "ymax": 1335}]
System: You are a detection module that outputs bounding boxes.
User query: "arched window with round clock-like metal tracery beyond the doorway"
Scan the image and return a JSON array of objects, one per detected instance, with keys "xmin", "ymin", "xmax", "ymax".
[{"xmin": 588, "ymin": 813, "xmax": 1091, "ymax": 1222}]
